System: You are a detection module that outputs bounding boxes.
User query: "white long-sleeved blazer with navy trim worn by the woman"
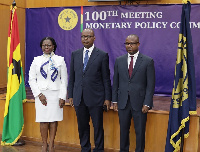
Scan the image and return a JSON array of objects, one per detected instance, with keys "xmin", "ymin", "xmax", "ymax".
[{"xmin": 29, "ymin": 55, "xmax": 68, "ymax": 100}]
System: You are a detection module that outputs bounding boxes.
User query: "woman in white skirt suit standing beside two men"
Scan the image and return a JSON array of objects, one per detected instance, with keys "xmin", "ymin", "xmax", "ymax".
[{"xmin": 29, "ymin": 37, "xmax": 68, "ymax": 152}]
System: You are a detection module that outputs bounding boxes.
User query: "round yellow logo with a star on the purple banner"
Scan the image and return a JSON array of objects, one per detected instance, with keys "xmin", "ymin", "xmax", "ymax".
[{"xmin": 58, "ymin": 9, "xmax": 78, "ymax": 30}]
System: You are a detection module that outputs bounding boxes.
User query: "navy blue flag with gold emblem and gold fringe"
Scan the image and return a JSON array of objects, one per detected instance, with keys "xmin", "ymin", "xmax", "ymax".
[{"xmin": 165, "ymin": 1, "xmax": 196, "ymax": 152}]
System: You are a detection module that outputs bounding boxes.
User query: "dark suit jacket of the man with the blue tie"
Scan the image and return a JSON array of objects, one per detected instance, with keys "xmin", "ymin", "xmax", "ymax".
[{"xmin": 68, "ymin": 47, "xmax": 112, "ymax": 106}]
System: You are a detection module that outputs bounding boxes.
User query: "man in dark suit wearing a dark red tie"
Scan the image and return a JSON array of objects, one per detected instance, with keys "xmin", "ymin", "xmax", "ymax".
[{"xmin": 112, "ymin": 35, "xmax": 155, "ymax": 152}]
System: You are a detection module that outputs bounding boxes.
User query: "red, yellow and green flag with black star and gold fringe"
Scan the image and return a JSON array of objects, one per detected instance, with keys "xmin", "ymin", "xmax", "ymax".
[{"xmin": 1, "ymin": 6, "xmax": 26, "ymax": 145}]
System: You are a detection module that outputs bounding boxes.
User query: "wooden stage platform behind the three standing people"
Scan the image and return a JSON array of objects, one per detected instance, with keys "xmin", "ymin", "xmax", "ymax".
[{"xmin": 0, "ymin": 88, "xmax": 200, "ymax": 152}]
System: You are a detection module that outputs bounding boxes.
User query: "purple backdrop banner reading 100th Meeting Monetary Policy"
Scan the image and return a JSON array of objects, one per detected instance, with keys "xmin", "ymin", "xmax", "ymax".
[{"xmin": 25, "ymin": 5, "xmax": 200, "ymax": 97}]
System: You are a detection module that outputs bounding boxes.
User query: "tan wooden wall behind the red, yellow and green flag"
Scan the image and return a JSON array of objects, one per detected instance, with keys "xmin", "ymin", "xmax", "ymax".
[{"xmin": 0, "ymin": 4, "xmax": 25, "ymax": 88}]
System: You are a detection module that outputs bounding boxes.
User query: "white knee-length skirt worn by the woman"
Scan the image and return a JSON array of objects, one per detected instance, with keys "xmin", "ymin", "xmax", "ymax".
[{"xmin": 35, "ymin": 90, "xmax": 63, "ymax": 122}]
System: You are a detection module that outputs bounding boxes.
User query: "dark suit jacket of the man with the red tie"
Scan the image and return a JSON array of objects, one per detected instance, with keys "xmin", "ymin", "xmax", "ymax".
[{"xmin": 112, "ymin": 53, "xmax": 155, "ymax": 111}]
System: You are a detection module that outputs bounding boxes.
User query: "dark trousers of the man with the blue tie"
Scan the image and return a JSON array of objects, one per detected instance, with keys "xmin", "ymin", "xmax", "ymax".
[{"xmin": 75, "ymin": 99, "xmax": 104, "ymax": 152}]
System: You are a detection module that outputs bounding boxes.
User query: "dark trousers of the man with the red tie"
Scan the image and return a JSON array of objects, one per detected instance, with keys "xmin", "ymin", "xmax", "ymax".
[{"xmin": 118, "ymin": 99, "xmax": 147, "ymax": 152}]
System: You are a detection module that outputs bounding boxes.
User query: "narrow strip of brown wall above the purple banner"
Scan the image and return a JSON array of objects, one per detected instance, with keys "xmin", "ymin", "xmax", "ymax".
[{"xmin": 26, "ymin": 0, "xmax": 200, "ymax": 8}]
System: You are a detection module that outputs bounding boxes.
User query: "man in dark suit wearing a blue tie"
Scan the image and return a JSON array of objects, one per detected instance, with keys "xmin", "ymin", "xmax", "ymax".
[{"xmin": 68, "ymin": 29, "xmax": 112, "ymax": 152}]
